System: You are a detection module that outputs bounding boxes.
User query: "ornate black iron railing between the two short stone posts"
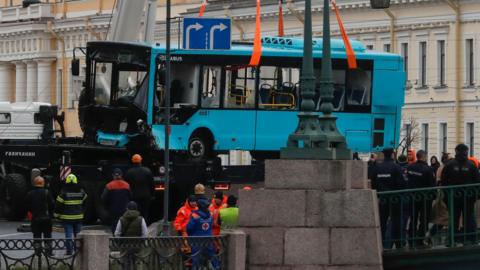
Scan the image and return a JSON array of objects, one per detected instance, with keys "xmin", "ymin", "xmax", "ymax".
[{"xmin": 110, "ymin": 236, "xmax": 228, "ymax": 270}]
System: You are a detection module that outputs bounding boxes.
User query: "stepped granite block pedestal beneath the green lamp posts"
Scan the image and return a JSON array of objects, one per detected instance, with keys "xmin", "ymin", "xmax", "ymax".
[{"xmin": 239, "ymin": 160, "xmax": 382, "ymax": 270}]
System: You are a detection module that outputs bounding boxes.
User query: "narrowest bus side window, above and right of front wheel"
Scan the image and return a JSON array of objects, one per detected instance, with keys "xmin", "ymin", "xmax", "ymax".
[{"xmin": 201, "ymin": 66, "xmax": 222, "ymax": 108}]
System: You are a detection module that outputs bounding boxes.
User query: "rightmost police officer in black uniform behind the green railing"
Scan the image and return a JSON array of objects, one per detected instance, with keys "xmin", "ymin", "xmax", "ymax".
[{"xmin": 441, "ymin": 144, "xmax": 479, "ymax": 245}]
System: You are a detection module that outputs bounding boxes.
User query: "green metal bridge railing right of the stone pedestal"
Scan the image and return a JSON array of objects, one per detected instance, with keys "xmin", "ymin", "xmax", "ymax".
[{"xmin": 378, "ymin": 183, "xmax": 480, "ymax": 250}]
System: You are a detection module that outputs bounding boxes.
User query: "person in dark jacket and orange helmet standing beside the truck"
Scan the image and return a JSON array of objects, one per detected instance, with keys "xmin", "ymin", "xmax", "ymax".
[{"xmin": 125, "ymin": 154, "xmax": 155, "ymax": 224}]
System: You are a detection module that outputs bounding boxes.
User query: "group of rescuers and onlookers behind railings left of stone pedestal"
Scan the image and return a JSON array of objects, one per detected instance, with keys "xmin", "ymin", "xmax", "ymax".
[{"xmin": 26, "ymin": 154, "xmax": 238, "ymax": 264}]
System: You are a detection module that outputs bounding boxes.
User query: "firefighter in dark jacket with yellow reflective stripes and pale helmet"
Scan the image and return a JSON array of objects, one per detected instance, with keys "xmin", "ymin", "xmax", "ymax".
[{"xmin": 54, "ymin": 174, "xmax": 87, "ymax": 255}]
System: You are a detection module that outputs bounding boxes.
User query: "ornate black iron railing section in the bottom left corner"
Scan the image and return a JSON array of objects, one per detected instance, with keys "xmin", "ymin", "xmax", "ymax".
[{"xmin": 0, "ymin": 239, "xmax": 82, "ymax": 270}]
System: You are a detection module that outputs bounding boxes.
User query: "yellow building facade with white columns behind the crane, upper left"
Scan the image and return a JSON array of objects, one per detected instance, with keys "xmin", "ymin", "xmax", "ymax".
[{"xmin": 0, "ymin": 0, "xmax": 201, "ymax": 136}]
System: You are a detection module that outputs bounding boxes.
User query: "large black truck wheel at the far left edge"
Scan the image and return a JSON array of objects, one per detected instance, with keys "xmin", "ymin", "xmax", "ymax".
[{"xmin": 2, "ymin": 173, "xmax": 28, "ymax": 221}]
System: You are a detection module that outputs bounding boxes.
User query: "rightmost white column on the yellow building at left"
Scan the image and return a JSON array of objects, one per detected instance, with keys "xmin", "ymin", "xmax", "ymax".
[{"xmin": 37, "ymin": 58, "xmax": 55, "ymax": 103}]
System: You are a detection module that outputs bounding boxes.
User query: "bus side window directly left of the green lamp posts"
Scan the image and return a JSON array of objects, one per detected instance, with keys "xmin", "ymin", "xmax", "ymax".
[{"xmin": 258, "ymin": 66, "xmax": 300, "ymax": 110}]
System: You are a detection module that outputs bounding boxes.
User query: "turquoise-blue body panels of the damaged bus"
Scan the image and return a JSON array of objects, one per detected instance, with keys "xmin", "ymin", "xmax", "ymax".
[{"xmin": 97, "ymin": 38, "xmax": 405, "ymax": 152}]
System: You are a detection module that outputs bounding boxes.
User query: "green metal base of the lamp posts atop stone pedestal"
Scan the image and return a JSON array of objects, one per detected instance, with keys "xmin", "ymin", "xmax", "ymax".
[{"xmin": 280, "ymin": 112, "xmax": 352, "ymax": 160}]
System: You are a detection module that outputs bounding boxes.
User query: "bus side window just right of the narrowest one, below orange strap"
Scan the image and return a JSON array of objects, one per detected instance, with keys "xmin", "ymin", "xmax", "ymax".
[{"xmin": 224, "ymin": 67, "xmax": 256, "ymax": 108}]
